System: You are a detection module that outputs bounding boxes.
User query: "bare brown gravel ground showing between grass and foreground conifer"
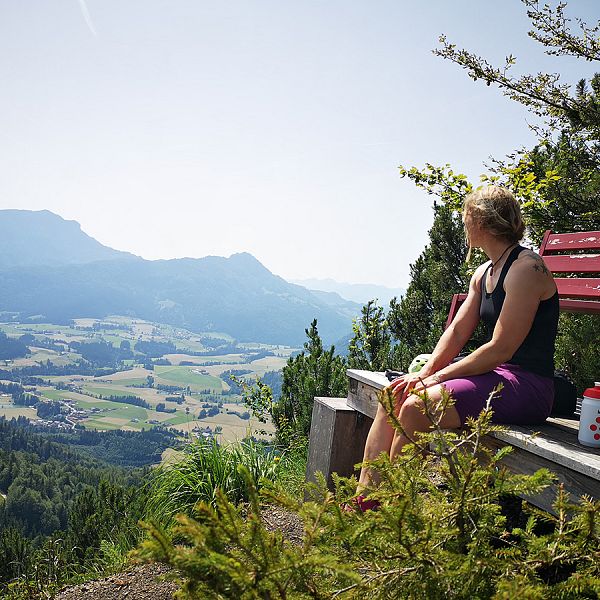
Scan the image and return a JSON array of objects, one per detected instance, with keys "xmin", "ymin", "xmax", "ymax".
[{"xmin": 55, "ymin": 506, "xmax": 303, "ymax": 600}]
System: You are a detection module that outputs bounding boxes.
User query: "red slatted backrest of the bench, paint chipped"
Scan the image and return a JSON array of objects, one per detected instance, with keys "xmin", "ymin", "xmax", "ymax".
[{"xmin": 446, "ymin": 231, "xmax": 600, "ymax": 327}]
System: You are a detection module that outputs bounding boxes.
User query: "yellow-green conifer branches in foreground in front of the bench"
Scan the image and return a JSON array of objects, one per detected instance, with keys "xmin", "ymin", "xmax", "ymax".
[{"xmin": 137, "ymin": 386, "xmax": 600, "ymax": 600}]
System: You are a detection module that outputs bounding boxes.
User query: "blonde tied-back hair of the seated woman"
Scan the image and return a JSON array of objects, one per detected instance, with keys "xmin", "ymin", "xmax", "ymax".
[{"xmin": 463, "ymin": 185, "xmax": 525, "ymax": 260}]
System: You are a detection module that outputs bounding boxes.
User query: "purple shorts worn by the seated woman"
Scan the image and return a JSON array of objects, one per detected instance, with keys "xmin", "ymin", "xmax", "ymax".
[{"xmin": 442, "ymin": 363, "xmax": 554, "ymax": 425}]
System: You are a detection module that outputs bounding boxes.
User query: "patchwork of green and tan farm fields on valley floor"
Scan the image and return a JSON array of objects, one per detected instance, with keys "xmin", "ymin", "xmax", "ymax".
[{"xmin": 0, "ymin": 316, "xmax": 295, "ymax": 441}]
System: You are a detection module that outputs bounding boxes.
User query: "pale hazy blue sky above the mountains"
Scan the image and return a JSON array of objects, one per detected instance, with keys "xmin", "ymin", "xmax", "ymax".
[{"xmin": 0, "ymin": 0, "xmax": 600, "ymax": 287}]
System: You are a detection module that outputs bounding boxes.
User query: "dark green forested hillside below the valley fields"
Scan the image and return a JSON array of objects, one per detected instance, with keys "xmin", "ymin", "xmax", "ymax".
[{"xmin": 0, "ymin": 418, "xmax": 178, "ymax": 594}]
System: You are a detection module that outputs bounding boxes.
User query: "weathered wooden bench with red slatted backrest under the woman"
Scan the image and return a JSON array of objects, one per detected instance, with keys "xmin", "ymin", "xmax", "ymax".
[{"xmin": 307, "ymin": 231, "xmax": 600, "ymax": 512}]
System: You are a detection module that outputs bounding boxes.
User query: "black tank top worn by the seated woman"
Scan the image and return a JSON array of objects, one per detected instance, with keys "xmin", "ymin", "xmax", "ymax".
[{"xmin": 479, "ymin": 246, "xmax": 558, "ymax": 377}]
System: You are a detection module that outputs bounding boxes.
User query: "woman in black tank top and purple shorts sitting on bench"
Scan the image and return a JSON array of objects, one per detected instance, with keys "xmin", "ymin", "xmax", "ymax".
[{"xmin": 357, "ymin": 186, "xmax": 559, "ymax": 508}]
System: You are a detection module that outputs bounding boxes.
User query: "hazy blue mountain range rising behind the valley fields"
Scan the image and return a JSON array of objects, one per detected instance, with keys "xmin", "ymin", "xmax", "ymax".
[{"xmin": 0, "ymin": 210, "xmax": 360, "ymax": 345}]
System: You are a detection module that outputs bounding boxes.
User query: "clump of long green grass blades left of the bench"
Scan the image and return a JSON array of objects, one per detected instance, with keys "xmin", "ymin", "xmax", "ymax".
[{"xmin": 146, "ymin": 439, "xmax": 306, "ymax": 525}]
